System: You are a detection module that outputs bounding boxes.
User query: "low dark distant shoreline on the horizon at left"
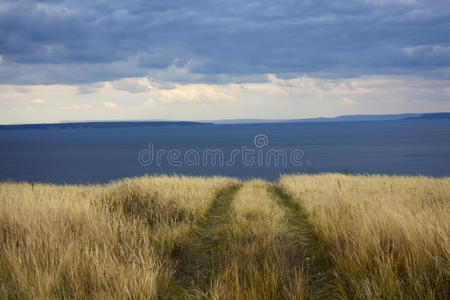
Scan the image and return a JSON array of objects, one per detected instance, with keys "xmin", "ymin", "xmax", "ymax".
[{"xmin": 0, "ymin": 121, "xmax": 212, "ymax": 130}]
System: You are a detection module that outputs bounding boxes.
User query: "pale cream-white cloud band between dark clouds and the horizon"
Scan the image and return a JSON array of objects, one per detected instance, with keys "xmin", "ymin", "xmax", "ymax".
[{"xmin": 0, "ymin": 70, "xmax": 450, "ymax": 123}]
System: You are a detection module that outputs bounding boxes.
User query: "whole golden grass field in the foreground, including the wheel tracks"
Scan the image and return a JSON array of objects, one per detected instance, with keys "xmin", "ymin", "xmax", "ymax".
[{"xmin": 0, "ymin": 174, "xmax": 450, "ymax": 299}]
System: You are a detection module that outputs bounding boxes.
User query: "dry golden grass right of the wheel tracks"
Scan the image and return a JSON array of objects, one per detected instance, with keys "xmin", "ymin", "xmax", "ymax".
[{"xmin": 280, "ymin": 174, "xmax": 450, "ymax": 299}]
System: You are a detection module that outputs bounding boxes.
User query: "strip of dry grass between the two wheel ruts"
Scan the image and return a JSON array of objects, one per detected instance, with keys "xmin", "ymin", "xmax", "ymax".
[{"xmin": 209, "ymin": 180, "xmax": 307, "ymax": 300}]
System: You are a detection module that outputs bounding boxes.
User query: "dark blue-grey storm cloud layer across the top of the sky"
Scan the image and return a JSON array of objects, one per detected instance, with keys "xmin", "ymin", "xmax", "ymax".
[{"xmin": 0, "ymin": 0, "xmax": 450, "ymax": 84}]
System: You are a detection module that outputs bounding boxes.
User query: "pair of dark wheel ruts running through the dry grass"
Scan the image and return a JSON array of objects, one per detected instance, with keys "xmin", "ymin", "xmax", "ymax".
[{"xmin": 161, "ymin": 185, "xmax": 334, "ymax": 299}]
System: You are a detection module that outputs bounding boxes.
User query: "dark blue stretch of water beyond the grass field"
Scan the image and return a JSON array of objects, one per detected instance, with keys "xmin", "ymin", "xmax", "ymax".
[{"xmin": 0, "ymin": 120, "xmax": 450, "ymax": 183}]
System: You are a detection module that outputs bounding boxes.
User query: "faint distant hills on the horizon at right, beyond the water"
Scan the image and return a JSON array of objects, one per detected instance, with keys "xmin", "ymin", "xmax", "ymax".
[{"xmin": 211, "ymin": 112, "xmax": 450, "ymax": 124}]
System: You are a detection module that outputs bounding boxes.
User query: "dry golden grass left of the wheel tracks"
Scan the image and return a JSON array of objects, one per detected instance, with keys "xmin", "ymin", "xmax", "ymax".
[{"xmin": 0, "ymin": 177, "xmax": 236, "ymax": 299}]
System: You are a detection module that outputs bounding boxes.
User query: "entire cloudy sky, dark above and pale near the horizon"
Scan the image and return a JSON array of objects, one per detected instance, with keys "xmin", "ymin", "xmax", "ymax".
[{"xmin": 0, "ymin": 0, "xmax": 450, "ymax": 124}]
